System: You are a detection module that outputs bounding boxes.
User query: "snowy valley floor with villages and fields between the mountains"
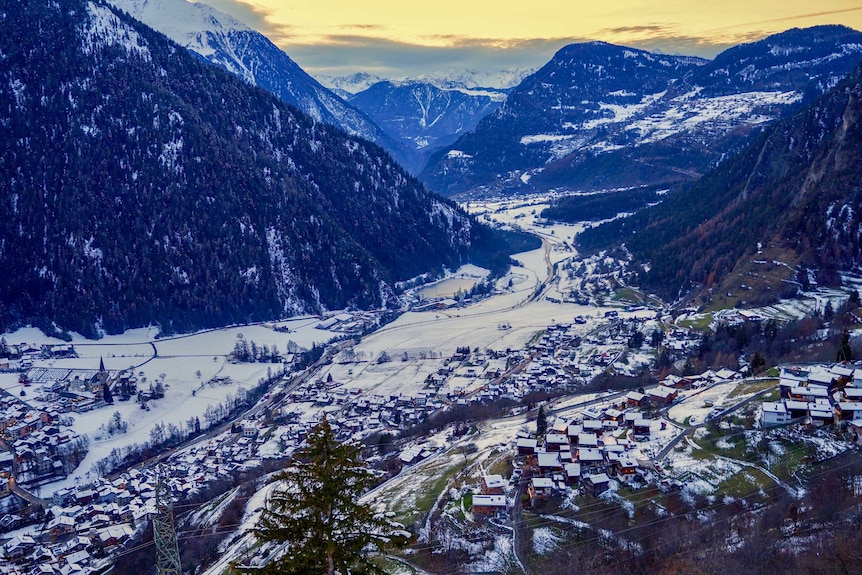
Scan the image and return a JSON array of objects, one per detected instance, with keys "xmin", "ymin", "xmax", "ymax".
[{"xmin": 0, "ymin": 195, "xmax": 862, "ymax": 575}]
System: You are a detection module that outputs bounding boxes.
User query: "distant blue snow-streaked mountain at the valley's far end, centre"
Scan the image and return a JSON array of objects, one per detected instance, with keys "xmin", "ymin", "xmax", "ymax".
[{"xmin": 349, "ymin": 80, "xmax": 506, "ymax": 159}]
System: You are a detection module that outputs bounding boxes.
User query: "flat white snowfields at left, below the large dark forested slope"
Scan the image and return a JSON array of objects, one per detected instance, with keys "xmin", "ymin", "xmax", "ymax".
[{"xmin": 0, "ymin": 317, "xmax": 337, "ymax": 496}]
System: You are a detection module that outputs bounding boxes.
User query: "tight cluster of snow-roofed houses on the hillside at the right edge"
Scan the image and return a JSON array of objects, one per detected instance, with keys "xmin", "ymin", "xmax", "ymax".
[{"xmin": 760, "ymin": 363, "xmax": 862, "ymax": 443}]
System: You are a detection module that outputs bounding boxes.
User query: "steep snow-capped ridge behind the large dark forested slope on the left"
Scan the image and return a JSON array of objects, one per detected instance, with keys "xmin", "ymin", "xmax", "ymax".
[{"xmin": 110, "ymin": 0, "xmax": 422, "ymax": 169}]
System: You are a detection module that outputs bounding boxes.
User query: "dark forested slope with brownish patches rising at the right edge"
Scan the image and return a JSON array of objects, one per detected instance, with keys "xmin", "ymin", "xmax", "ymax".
[{"xmin": 579, "ymin": 59, "xmax": 862, "ymax": 306}]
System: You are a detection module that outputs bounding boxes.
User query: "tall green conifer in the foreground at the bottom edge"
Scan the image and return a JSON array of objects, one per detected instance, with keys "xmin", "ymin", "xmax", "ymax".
[{"xmin": 254, "ymin": 419, "xmax": 408, "ymax": 575}]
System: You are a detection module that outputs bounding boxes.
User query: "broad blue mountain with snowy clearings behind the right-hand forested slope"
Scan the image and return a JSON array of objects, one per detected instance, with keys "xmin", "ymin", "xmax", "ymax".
[{"xmin": 420, "ymin": 26, "xmax": 862, "ymax": 194}]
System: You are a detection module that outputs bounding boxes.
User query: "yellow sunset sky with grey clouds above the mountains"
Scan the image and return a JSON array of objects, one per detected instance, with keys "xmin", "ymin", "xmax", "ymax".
[{"xmin": 203, "ymin": 0, "xmax": 862, "ymax": 78}]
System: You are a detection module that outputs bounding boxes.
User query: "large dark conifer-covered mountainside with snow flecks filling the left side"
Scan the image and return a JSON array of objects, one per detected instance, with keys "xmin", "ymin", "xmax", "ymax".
[{"xmin": 0, "ymin": 0, "xmax": 532, "ymax": 335}]
